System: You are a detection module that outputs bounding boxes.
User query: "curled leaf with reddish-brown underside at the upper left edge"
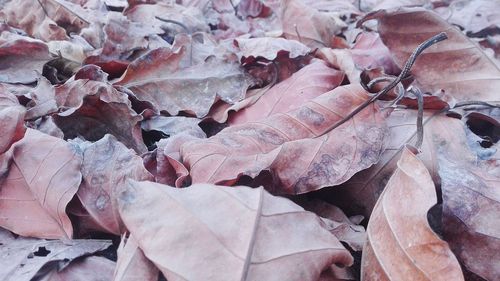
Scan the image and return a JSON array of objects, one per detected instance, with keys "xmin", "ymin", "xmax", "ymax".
[{"xmin": 0, "ymin": 39, "xmax": 52, "ymax": 84}]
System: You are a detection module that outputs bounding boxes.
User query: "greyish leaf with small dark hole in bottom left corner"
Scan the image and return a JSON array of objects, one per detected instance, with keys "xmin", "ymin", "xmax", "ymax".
[{"xmin": 0, "ymin": 228, "xmax": 112, "ymax": 281}]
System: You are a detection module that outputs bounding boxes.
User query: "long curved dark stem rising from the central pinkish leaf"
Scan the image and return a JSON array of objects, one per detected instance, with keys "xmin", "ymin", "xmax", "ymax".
[{"xmin": 326, "ymin": 32, "xmax": 448, "ymax": 132}]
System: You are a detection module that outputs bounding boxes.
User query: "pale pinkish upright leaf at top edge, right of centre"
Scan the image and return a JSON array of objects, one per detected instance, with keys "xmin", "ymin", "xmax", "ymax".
[{"xmin": 280, "ymin": 0, "xmax": 346, "ymax": 48}]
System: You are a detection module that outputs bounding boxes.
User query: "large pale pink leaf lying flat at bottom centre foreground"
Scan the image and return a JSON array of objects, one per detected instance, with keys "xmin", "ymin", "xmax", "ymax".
[{"xmin": 119, "ymin": 181, "xmax": 353, "ymax": 281}]
